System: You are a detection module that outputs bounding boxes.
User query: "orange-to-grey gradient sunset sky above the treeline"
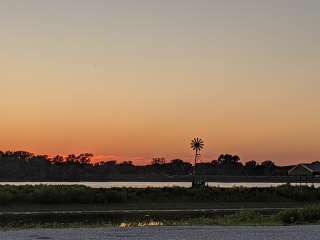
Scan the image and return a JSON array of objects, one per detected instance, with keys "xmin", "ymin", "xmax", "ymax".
[{"xmin": 0, "ymin": 0, "xmax": 320, "ymax": 164}]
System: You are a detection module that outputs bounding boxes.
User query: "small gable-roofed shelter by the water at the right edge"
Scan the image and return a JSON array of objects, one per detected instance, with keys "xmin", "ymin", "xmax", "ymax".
[{"xmin": 288, "ymin": 162, "xmax": 320, "ymax": 184}]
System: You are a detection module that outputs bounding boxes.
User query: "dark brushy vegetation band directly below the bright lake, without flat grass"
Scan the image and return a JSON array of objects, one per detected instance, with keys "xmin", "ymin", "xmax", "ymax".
[{"xmin": 0, "ymin": 185, "xmax": 320, "ymax": 204}]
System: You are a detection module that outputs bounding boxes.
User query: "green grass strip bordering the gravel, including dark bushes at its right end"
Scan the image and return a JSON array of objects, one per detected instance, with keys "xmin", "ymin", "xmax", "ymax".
[{"xmin": 0, "ymin": 205, "xmax": 320, "ymax": 230}]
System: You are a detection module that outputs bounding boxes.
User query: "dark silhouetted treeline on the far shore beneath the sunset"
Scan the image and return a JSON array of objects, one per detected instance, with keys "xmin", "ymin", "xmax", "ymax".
[{"xmin": 0, "ymin": 151, "xmax": 290, "ymax": 181}]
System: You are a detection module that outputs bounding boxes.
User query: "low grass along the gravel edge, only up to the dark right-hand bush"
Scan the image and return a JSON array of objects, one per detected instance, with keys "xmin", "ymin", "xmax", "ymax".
[{"xmin": 0, "ymin": 211, "xmax": 283, "ymax": 230}]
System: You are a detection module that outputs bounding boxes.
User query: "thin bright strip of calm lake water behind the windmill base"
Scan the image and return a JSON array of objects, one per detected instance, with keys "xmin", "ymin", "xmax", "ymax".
[{"xmin": 0, "ymin": 182, "xmax": 320, "ymax": 188}]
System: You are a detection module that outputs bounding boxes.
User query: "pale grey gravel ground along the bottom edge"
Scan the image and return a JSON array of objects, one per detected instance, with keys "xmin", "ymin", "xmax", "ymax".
[{"xmin": 0, "ymin": 225, "xmax": 320, "ymax": 240}]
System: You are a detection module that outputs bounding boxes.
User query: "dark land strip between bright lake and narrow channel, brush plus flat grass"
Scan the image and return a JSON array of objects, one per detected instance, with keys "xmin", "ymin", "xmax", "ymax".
[{"xmin": 0, "ymin": 185, "xmax": 320, "ymax": 212}]
